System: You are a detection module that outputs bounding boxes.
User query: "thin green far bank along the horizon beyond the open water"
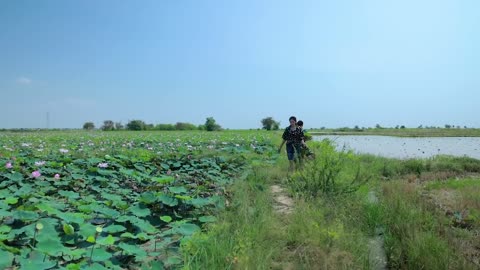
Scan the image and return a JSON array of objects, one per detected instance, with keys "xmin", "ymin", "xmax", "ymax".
[{"xmin": 310, "ymin": 128, "xmax": 480, "ymax": 137}]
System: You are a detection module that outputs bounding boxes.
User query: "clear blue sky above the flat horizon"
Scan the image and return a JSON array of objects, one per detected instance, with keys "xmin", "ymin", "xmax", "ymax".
[{"xmin": 0, "ymin": 0, "xmax": 480, "ymax": 128}]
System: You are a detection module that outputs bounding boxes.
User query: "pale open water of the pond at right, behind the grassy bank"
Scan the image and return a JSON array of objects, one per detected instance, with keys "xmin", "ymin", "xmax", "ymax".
[{"xmin": 313, "ymin": 135, "xmax": 480, "ymax": 159}]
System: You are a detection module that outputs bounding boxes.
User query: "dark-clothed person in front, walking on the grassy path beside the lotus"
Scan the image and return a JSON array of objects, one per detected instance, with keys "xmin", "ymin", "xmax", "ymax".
[{"xmin": 278, "ymin": 116, "xmax": 304, "ymax": 171}]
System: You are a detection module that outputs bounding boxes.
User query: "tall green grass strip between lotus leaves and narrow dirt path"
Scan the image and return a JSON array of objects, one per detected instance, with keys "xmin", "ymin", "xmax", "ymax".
[{"xmin": 182, "ymin": 163, "xmax": 285, "ymax": 269}]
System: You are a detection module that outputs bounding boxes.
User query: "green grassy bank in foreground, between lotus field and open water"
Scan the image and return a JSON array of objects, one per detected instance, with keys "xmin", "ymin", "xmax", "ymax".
[{"xmin": 182, "ymin": 138, "xmax": 480, "ymax": 269}]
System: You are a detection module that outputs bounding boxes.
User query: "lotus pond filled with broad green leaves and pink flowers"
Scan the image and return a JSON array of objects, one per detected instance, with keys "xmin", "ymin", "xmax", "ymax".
[{"xmin": 0, "ymin": 131, "xmax": 277, "ymax": 270}]
